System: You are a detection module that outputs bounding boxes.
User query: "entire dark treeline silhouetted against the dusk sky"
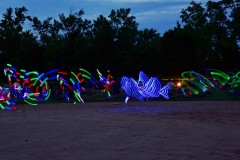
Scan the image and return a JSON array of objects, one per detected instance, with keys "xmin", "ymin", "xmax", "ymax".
[{"xmin": 0, "ymin": 0, "xmax": 240, "ymax": 81}]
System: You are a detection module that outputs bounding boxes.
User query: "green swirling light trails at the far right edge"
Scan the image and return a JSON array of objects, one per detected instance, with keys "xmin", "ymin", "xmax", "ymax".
[{"xmin": 181, "ymin": 69, "xmax": 240, "ymax": 97}]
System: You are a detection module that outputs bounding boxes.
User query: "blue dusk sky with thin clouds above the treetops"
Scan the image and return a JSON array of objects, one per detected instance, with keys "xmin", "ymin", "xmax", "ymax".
[{"xmin": 0, "ymin": 0, "xmax": 212, "ymax": 35}]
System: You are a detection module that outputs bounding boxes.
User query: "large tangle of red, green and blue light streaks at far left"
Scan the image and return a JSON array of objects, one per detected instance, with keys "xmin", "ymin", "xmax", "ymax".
[{"xmin": 0, "ymin": 64, "xmax": 97, "ymax": 109}]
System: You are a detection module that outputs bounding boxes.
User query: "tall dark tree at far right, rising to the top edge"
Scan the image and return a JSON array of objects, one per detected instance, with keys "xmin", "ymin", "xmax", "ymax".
[{"xmin": 180, "ymin": 0, "xmax": 239, "ymax": 69}]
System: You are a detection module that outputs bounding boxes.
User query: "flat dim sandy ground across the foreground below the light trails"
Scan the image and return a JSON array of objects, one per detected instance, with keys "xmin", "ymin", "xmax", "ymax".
[{"xmin": 0, "ymin": 101, "xmax": 240, "ymax": 160}]
